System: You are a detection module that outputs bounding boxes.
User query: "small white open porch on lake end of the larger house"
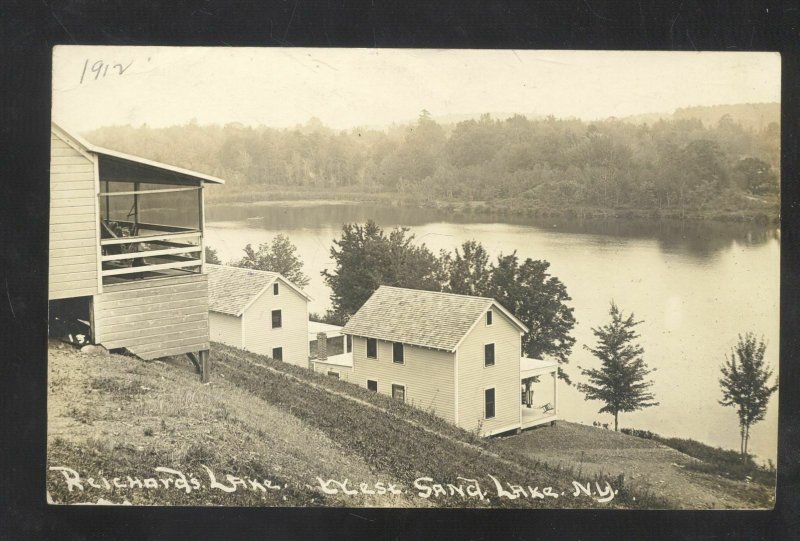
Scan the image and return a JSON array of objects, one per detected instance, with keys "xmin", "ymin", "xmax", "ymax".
[{"xmin": 519, "ymin": 357, "xmax": 558, "ymax": 430}]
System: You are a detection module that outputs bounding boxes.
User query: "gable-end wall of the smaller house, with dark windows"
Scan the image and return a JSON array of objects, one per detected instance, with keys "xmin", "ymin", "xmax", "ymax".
[{"xmin": 242, "ymin": 278, "xmax": 308, "ymax": 367}]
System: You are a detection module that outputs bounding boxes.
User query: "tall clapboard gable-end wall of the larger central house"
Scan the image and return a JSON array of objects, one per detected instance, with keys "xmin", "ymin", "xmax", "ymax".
[{"xmin": 458, "ymin": 308, "xmax": 520, "ymax": 433}]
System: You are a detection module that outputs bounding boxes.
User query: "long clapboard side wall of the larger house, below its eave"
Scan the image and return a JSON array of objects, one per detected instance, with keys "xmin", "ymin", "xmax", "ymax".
[{"xmin": 350, "ymin": 336, "xmax": 455, "ymax": 423}]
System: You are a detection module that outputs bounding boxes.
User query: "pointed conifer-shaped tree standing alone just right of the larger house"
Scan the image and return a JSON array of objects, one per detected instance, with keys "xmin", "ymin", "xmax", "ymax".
[{"xmin": 578, "ymin": 301, "xmax": 658, "ymax": 431}]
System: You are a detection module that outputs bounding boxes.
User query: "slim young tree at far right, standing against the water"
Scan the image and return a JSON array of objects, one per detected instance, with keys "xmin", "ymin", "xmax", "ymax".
[{"xmin": 719, "ymin": 333, "xmax": 778, "ymax": 456}]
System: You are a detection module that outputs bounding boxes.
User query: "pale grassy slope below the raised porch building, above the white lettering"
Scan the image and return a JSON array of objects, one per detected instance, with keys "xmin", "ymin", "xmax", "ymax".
[{"xmin": 48, "ymin": 342, "xmax": 420, "ymax": 507}]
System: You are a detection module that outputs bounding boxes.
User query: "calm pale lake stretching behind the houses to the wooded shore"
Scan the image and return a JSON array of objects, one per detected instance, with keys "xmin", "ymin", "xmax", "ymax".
[{"xmin": 206, "ymin": 202, "xmax": 780, "ymax": 461}]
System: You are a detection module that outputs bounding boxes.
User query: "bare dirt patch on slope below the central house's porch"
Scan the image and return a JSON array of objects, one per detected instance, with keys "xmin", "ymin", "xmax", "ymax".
[{"xmin": 495, "ymin": 421, "xmax": 770, "ymax": 509}]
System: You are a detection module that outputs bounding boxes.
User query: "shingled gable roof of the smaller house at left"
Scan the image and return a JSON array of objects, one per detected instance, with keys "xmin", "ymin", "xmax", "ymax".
[{"xmin": 206, "ymin": 264, "xmax": 311, "ymax": 317}]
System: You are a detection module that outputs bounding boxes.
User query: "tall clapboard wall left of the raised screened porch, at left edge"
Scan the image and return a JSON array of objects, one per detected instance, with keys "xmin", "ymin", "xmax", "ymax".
[{"xmin": 49, "ymin": 132, "xmax": 98, "ymax": 299}]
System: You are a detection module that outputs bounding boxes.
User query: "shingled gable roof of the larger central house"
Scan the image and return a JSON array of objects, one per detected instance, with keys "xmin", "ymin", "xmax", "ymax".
[{"xmin": 342, "ymin": 286, "xmax": 528, "ymax": 351}]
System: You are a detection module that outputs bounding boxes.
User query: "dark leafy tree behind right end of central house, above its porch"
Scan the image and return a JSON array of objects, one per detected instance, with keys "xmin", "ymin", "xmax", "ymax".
[{"xmin": 479, "ymin": 252, "xmax": 575, "ymax": 383}]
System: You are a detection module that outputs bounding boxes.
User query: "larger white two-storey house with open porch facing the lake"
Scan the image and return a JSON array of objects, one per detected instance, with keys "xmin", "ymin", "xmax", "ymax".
[{"xmin": 342, "ymin": 286, "xmax": 558, "ymax": 435}]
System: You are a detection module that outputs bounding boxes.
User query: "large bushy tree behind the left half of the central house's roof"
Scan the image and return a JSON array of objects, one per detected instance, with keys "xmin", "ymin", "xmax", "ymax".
[{"xmin": 322, "ymin": 220, "xmax": 444, "ymax": 321}]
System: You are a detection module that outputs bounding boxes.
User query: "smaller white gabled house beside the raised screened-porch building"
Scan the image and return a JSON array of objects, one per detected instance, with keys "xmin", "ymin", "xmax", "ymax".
[{"xmin": 206, "ymin": 265, "xmax": 310, "ymax": 368}]
